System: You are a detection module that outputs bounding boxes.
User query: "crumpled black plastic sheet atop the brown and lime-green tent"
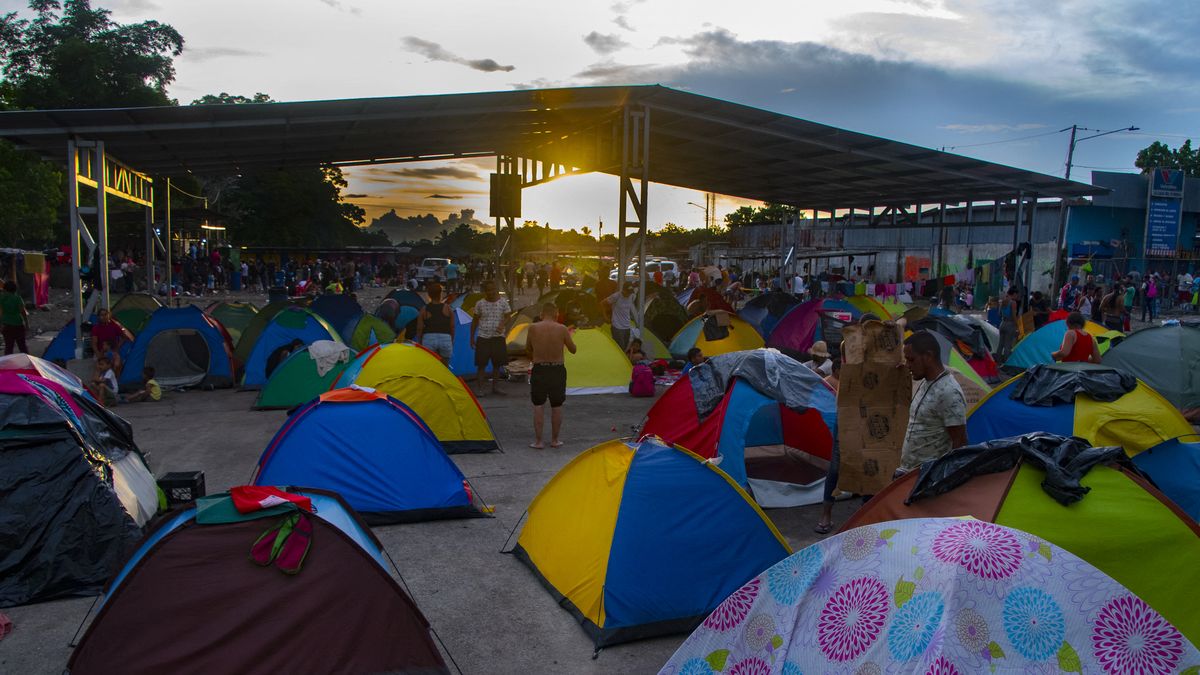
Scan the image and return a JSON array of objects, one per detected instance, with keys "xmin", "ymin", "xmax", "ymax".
[{"xmin": 905, "ymin": 431, "xmax": 1136, "ymax": 506}]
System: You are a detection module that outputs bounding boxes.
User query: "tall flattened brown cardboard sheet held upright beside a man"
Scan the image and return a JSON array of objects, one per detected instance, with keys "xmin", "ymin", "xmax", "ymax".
[{"xmin": 838, "ymin": 321, "xmax": 912, "ymax": 495}]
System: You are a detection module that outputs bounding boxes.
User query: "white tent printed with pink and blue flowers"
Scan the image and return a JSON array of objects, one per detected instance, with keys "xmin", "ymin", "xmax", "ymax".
[{"xmin": 661, "ymin": 518, "xmax": 1200, "ymax": 675}]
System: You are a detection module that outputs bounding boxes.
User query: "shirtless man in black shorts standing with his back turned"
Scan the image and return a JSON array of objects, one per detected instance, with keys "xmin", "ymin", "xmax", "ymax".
[{"xmin": 526, "ymin": 303, "xmax": 575, "ymax": 449}]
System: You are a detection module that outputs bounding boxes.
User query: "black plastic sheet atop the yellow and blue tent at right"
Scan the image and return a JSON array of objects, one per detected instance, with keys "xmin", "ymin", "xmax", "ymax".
[{"xmin": 1008, "ymin": 364, "xmax": 1138, "ymax": 406}]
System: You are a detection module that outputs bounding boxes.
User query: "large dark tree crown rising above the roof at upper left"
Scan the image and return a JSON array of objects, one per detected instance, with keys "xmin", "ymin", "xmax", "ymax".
[{"xmin": 0, "ymin": 0, "xmax": 184, "ymax": 108}]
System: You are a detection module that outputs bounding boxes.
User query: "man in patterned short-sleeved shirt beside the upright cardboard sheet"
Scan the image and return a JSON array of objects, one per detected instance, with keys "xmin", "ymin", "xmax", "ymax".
[{"xmin": 896, "ymin": 330, "xmax": 967, "ymax": 476}]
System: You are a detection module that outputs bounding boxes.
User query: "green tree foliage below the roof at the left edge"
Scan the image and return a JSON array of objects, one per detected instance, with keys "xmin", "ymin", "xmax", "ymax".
[{"xmin": 0, "ymin": 142, "xmax": 66, "ymax": 242}]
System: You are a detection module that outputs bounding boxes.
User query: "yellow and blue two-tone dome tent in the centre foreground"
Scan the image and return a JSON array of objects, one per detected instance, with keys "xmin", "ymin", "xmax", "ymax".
[{"xmin": 512, "ymin": 440, "xmax": 791, "ymax": 649}]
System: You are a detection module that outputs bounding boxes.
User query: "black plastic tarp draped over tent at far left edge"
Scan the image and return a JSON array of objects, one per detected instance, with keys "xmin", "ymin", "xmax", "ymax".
[{"xmin": 0, "ymin": 430, "xmax": 142, "ymax": 607}]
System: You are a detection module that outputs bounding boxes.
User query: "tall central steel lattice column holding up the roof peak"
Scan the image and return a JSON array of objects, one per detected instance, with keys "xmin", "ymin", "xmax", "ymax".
[{"xmin": 617, "ymin": 106, "xmax": 650, "ymax": 331}]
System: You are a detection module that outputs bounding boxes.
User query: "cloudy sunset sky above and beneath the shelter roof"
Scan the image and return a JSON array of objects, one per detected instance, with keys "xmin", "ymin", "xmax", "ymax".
[{"xmin": 11, "ymin": 0, "xmax": 1200, "ymax": 232}]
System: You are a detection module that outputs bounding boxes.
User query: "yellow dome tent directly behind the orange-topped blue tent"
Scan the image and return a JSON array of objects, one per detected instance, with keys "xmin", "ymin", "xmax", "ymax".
[{"xmin": 334, "ymin": 342, "xmax": 499, "ymax": 454}]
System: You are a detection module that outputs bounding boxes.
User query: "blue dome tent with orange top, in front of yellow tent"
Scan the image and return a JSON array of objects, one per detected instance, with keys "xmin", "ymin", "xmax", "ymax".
[{"xmin": 253, "ymin": 387, "xmax": 481, "ymax": 524}]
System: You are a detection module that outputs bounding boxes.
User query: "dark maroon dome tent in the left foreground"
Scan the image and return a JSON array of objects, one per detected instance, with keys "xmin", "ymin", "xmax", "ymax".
[{"xmin": 67, "ymin": 489, "xmax": 449, "ymax": 675}]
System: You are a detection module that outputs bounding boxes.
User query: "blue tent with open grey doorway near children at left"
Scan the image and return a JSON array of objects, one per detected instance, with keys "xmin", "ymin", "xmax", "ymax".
[{"xmin": 121, "ymin": 305, "xmax": 233, "ymax": 388}]
